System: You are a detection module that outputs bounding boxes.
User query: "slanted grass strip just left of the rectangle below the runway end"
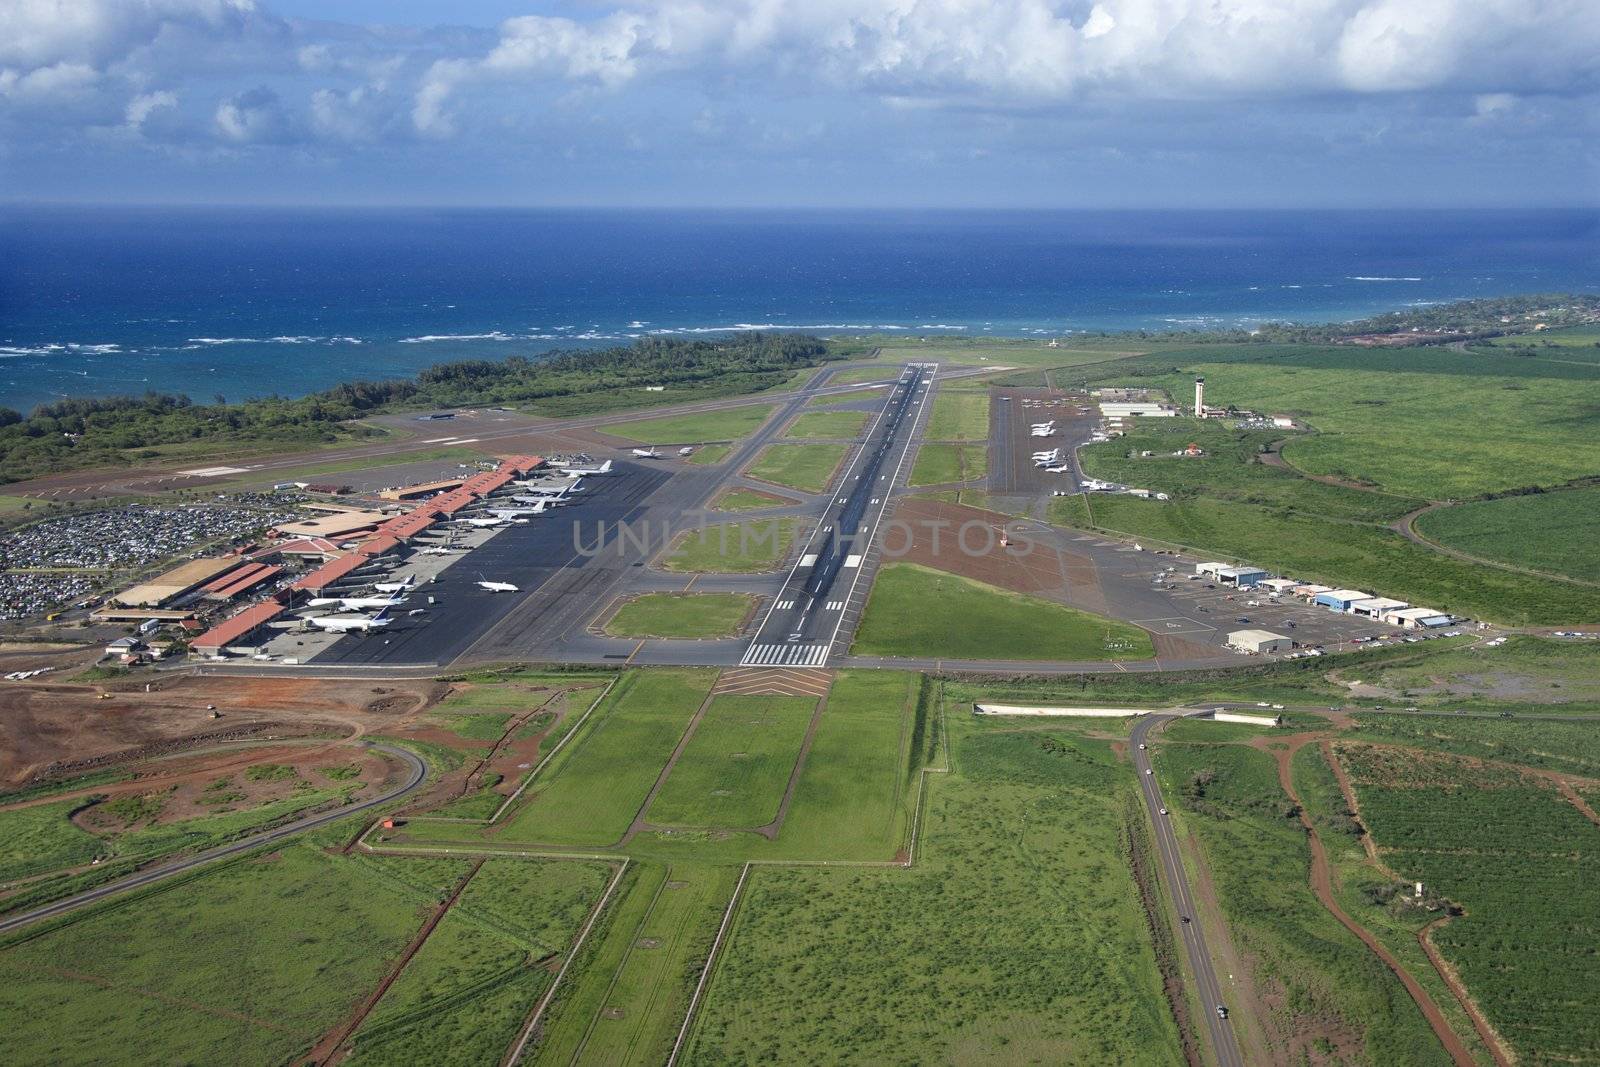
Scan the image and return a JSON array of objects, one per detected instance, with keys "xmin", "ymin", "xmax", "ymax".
[{"xmin": 499, "ymin": 670, "xmax": 715, "ymax": 845}]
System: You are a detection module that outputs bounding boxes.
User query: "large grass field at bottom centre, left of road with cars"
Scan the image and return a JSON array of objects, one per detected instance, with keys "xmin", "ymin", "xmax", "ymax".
[{"xmin": 688, "ymin": 715, "xmax": 1182, "ymax": 1064}]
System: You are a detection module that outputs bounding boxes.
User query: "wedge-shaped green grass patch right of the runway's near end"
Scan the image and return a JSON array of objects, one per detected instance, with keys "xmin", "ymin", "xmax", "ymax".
[{"xmin": 851, "ymin": 563, "xmax": 1155, "ymax": 661}]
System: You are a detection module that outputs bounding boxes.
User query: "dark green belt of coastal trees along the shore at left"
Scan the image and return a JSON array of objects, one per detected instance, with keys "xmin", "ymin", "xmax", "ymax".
[{"xmin": 0, "ymin": 333, "xmax": 830, "ymax": 482}]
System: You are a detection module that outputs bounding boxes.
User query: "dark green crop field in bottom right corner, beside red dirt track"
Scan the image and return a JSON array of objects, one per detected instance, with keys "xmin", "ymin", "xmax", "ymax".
[{"xmin": 1349, "ymin": 748, "xmax": 1600, "ymax": 1064}]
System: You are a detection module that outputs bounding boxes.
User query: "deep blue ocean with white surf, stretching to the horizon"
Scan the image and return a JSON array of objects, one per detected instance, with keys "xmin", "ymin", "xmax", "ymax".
[{"xmin": 0, "ymin": 206, "xmax": 1600, "ymax": 410}]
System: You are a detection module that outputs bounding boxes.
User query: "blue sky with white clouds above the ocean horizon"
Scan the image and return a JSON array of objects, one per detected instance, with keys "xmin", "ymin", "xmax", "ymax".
[{"xmin": 0, "ymin": 0, "xmax": 1600, "ymax": 208}]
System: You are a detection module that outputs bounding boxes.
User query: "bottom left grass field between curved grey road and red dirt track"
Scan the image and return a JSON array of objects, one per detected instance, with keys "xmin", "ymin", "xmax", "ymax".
[{"xmin": 0, "ymin": 841, "xmax": 466, "ymax": 1064}]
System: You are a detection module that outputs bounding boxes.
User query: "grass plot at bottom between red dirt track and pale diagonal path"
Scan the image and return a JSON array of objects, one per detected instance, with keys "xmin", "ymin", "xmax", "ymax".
[{"xmin": 347, "ymin": 859, "xmax": 611, "ymax": 1064}]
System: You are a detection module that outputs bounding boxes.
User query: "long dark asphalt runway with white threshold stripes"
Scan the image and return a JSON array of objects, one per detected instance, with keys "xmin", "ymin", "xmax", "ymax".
[{"xmin": 741, "ymin": 363, "xmax": 938, "ymax": 667}]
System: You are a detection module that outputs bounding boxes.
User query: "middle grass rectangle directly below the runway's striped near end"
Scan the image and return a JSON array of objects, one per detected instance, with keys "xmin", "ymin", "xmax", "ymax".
[{"xmin": 645, "ymin": 696, "xmax": 816, "ymax": 829}]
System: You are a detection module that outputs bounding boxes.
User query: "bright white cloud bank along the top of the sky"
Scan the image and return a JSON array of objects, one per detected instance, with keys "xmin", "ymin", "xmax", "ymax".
[{"xmin": 414, "ymin": 0, "xmax": 1600, "ymax": 133}]
